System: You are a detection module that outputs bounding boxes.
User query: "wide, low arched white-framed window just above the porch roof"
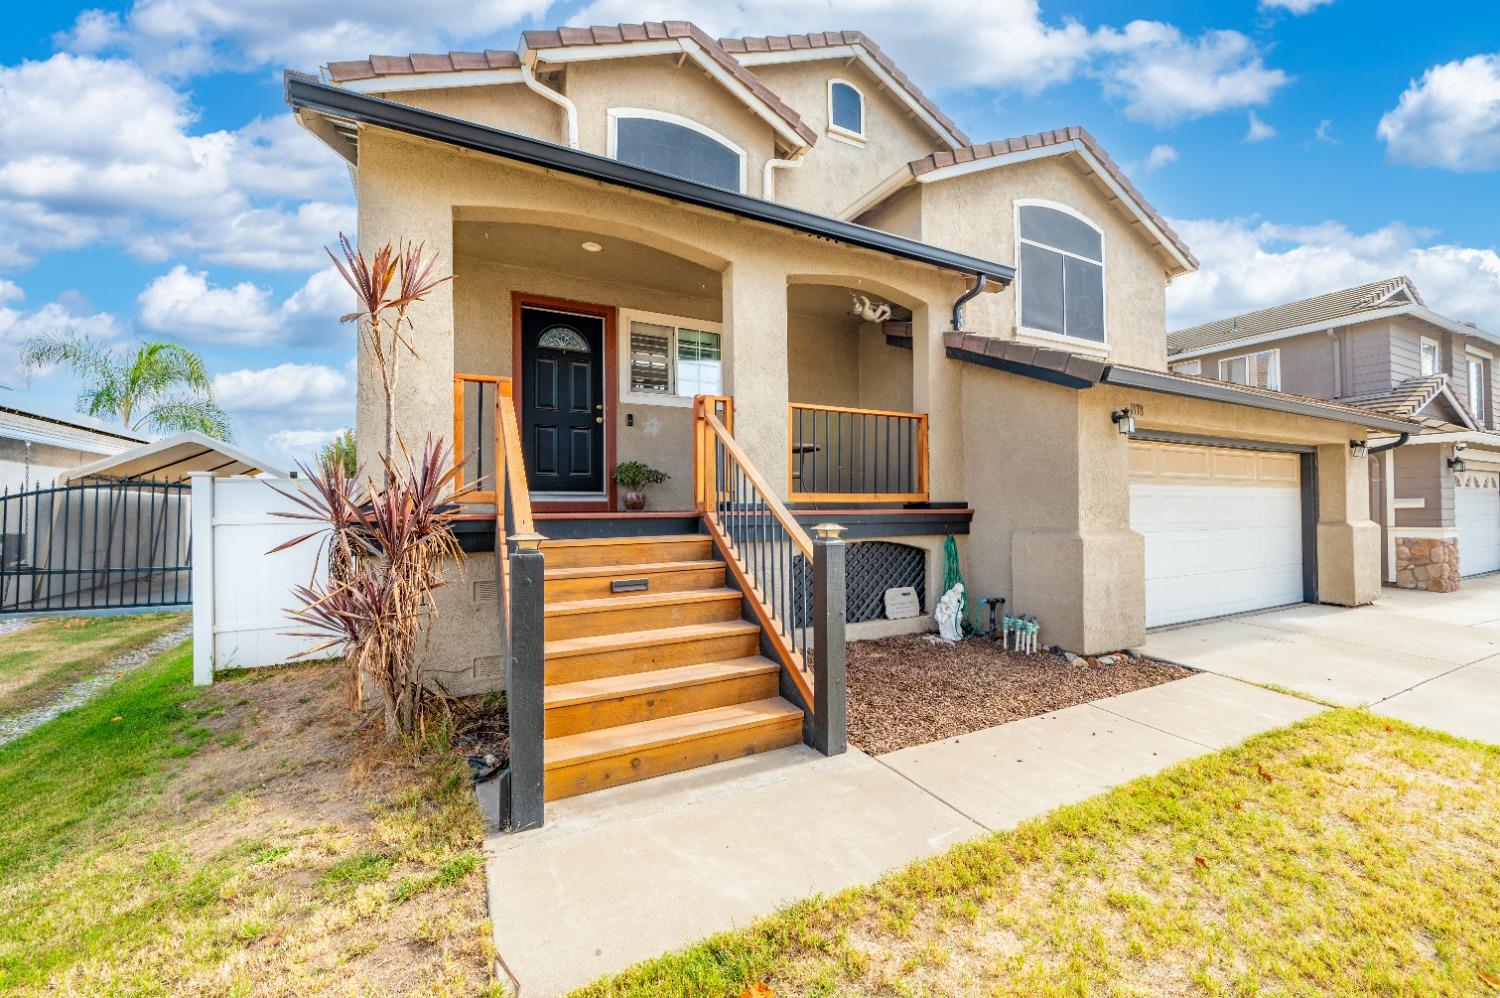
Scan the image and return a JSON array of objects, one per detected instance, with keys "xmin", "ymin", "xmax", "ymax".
[{"xmin": 609, "ymin": 108, "xmax": 746, "ymax": 194}]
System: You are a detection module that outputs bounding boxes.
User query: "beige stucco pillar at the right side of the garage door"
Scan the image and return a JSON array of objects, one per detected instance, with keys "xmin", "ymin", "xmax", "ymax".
[{"xmin": 1317, "ymin": 443, "xmax": 1380, "ymax": 606}]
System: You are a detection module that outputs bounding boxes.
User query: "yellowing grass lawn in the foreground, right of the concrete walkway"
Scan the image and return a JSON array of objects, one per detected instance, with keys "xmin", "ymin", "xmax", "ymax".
[{"xmin": 581, "ymin": 710, "xmax": 1500, "ymax": 998}]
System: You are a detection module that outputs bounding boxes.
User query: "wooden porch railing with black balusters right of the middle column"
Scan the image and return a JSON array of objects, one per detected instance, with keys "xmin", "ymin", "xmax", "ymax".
[{"xmin": 786, "ymin": 402, "xmax": 930, "ymax": 503}]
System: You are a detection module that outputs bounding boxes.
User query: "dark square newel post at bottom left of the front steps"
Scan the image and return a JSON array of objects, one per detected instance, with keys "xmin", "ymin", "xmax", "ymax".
[{"xmin": 503, "ymin": 534, "xmax": 545, "ymax": 831}]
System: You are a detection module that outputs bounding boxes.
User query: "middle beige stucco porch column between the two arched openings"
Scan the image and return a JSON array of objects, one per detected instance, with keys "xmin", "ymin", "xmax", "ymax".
[{"xmin": 723, "ymin": 254, "xmax": 791, "ymax": 498}]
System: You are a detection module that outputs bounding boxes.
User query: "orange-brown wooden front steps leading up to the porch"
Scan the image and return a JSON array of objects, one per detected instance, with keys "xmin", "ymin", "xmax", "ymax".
[{"xmin": 543, "ymin": 534, "xmax": 803, "ymax": 800}]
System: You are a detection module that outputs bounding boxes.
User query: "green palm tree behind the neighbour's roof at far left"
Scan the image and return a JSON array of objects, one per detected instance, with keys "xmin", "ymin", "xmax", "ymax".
[{"xmin": 21, "ymin": 332, "xmax": 234, "ymax": 440}]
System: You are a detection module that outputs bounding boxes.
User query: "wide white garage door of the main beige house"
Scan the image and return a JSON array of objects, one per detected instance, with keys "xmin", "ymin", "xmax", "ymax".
[{"xmin": 1130, "ymin": 440, "xmax": 1304, "ymax": 627}]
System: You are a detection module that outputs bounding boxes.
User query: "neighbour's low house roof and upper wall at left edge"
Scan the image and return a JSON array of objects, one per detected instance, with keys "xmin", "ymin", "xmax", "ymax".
[{"xmin": 0, "ymin": 405, "xmax": 146, "ymax": 492}]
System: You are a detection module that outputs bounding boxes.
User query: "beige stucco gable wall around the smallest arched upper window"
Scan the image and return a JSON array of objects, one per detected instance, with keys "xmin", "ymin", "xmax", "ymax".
[{"xmin": 753, "ymin": 59, "xmax": 945, "ymax": 215}]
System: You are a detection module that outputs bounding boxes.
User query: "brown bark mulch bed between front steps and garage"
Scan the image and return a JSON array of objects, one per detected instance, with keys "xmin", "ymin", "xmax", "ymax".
[{"xmin": 849, "ymin": 635, "xmax": 1193, "ymax": 755}]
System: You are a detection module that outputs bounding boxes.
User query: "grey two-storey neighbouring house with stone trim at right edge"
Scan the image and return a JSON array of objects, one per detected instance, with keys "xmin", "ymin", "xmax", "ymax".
[{"xmin": 1167, "ymin": 278, "xmax": 1500, "ymax": 593}]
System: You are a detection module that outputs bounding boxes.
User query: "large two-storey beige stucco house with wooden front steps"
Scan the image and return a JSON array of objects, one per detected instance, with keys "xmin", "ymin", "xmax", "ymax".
[{"xmin": 287, "ymin": 23, "xmax": 1415, "ymax": 795}]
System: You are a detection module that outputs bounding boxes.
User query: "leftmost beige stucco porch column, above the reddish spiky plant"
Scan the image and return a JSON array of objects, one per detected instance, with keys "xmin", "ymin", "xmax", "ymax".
[{"xmin": 356, "ymin": 134, "xmax": 453, "ymax": 471}]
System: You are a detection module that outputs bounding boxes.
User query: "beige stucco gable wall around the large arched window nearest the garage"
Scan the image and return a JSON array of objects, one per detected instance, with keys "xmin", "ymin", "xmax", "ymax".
[{"xmin": 923, "ymin": 156, "xmax": 1167, "ymax": 371}]
